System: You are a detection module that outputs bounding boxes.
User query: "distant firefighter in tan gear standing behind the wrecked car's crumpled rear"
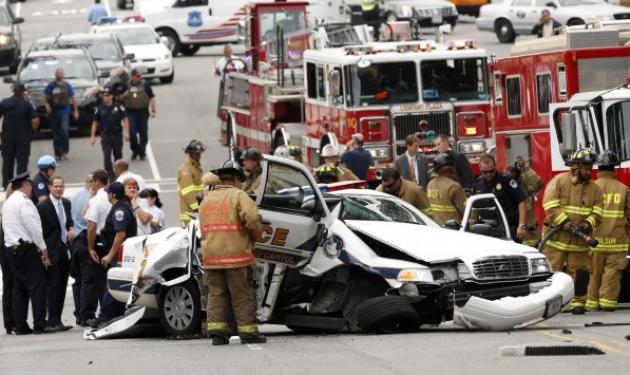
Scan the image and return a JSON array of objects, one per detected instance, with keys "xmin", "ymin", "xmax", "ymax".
[{"xmin": 177, "ymin": 139, "xmax": 206, "ymax": 227}]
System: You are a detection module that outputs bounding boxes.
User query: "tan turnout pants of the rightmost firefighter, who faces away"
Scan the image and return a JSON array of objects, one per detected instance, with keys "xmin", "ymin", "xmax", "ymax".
[{"xmin": 586, "ymin": 251, "xmax": 628, "ymax": 310}]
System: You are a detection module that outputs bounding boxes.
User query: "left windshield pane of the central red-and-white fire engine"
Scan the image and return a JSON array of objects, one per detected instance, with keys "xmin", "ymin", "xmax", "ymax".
[{"xmin": 346, "ymin": 61, "xmax": 418, "ymax": 107}]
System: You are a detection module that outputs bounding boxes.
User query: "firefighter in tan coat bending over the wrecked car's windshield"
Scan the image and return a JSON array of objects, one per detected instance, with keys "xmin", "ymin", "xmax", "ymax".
[{"xmin": 376, "ymin": 168, "xmax": 431, "ymax": 215}]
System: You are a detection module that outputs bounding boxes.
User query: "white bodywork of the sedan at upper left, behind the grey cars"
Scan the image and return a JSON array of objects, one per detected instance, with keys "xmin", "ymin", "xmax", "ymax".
[{"xmin": 92, "ymin": 22, "xmax": 175, "ymax": 83}]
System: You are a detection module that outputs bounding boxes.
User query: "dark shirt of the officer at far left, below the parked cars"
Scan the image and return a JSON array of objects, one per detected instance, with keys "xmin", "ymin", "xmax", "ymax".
[{"xmin": 0, "ymin": 95, "xmax": 37, "ymax": 140}]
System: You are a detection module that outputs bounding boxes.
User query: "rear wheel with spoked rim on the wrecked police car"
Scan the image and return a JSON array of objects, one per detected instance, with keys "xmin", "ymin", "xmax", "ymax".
[{"xmin": 159, "ymin": 280, "xmax": 201, "ymax": 336}]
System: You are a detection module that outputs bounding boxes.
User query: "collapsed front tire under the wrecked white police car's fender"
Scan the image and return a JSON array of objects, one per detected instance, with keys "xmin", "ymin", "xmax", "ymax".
[{"xmin": 357, "ymin": 296, "xmax": 420, "ymax": 333}]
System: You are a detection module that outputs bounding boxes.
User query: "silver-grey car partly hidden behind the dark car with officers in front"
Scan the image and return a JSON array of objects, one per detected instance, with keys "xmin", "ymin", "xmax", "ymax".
[{"xmin": 29, "ymin": 33, "xmax": 134, "ymax": 84}]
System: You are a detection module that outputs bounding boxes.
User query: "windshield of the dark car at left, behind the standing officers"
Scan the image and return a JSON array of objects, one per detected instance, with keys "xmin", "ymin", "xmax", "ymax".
[{"xmin": 19, "ymin": 56, "xmax": 96, "ymax": 81}]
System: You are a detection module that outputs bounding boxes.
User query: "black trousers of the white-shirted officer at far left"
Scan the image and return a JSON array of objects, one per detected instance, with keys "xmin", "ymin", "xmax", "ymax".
[{"xmin": 7, "ymin": 245, "xmax": 46, "ymax": 332}]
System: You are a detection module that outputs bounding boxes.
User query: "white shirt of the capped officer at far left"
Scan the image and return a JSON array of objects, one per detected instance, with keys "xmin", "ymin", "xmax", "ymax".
[{"xmin": 2, "ymin": 190, "xmax": 46, "ymax": 251}]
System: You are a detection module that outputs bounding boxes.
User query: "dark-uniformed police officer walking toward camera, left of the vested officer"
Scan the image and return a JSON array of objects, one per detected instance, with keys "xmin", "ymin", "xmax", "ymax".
[{"xmin": 90, "ymin": 89, "xmax": 129, "ymax": 180}]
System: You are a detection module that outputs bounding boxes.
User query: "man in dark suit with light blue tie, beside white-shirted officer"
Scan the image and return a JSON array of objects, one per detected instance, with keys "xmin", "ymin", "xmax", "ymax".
[{"xmin": 37, "ymin": 176, "xmax": 74, "ymax": 331}]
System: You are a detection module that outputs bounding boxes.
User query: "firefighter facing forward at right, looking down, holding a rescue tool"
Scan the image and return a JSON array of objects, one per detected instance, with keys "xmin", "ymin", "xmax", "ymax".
[{"xmin": 543, "ymin": 148, "xmax": 603, "ymax": 314}]
